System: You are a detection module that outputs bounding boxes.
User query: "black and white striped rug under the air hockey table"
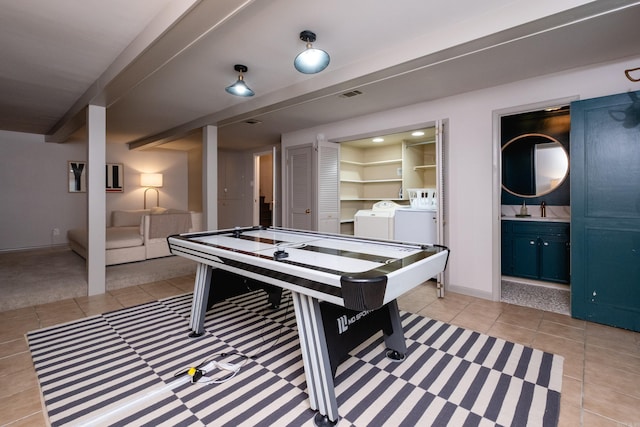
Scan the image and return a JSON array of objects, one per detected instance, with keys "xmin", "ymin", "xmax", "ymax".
[{"xmin": 27, "ymin": 291, "xmax": 563, "ymax": 426}]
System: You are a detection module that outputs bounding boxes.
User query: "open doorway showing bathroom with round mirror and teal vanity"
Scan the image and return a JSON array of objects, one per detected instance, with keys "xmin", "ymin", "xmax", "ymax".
[{"xmin": 498, "ymin": 102, "xmax": 571, "ymax": 315}]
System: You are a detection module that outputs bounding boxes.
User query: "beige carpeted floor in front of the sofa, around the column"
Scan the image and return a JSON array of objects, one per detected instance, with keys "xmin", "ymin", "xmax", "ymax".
[{"xmin": 0, "ymin": 248, "xmax": 196, "ymax": 311}]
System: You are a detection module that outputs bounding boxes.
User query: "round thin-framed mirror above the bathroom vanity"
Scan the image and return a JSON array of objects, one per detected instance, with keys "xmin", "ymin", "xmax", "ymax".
[{"xmin": 502, "ymin": 133, "xmax": 569, "ymax": 197}]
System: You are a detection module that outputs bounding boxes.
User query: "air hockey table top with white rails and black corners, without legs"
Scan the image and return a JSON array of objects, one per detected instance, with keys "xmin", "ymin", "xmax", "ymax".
[{"xmin": 168, "ymin": 227, "xmax": 449, "ymax": 310}]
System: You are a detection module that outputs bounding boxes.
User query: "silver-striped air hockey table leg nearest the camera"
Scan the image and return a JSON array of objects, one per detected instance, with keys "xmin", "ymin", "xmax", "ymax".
[{"xmin": 291, "ymin": 292, "xmax": 339, "ymax": 426}]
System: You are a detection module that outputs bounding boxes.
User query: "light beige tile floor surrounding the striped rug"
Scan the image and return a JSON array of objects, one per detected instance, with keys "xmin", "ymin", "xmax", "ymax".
[{"xmin": 0, "ymin": 276, "xmax": 640, "ymax": 427}]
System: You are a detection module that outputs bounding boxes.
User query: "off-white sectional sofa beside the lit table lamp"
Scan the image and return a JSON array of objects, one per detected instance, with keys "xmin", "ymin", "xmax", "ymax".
[{"xmin": 67, "ymin": 208, "xmax": 202, "ymax": 265}]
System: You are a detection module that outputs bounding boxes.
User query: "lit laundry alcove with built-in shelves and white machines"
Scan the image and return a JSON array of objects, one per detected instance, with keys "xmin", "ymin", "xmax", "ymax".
[{"xmin": 340, "ymin": 127, "xmax": 439, "ymax": 243}]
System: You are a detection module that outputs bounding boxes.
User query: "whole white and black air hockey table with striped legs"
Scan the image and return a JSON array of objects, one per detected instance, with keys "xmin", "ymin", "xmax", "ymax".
[{"xmin": 167, "ymin": 227, "xmax": 449, "ymax": 425}]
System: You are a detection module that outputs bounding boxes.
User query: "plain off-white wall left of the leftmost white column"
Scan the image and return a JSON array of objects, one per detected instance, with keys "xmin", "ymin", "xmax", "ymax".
[{"xmin": 0, "ymin": 131, "xmax": 87, "ymax": 250}]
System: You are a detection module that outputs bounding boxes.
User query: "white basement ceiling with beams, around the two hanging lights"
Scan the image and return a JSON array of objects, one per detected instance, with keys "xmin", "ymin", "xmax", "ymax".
[{"xmin": 0, "ymin": 0, "xmax": 640, "ymax": 149}]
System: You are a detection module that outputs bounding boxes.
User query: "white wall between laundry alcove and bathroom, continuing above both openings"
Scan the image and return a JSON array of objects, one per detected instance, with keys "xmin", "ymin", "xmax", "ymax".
[{"xmin": 282, "ymin": 57, "xmax": 640, "ymax": 299}]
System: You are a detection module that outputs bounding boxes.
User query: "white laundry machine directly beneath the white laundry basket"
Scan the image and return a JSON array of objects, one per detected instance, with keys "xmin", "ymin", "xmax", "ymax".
[{"xmin": 394, "ymin": 208, "xmax": 438, "ymax": 244}]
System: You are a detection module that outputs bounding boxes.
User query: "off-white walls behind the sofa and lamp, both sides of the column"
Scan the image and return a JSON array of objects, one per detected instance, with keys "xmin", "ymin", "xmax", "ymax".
[{"xmin": 0, "ymin": 131, "xmax": 188, "ymax": 251}]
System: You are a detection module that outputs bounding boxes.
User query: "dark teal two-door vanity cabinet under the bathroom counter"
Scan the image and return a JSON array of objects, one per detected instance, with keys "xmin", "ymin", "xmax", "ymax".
[{"xmin": 502, "ymin": 219, "xmax": 570, "ymax": 283}]
